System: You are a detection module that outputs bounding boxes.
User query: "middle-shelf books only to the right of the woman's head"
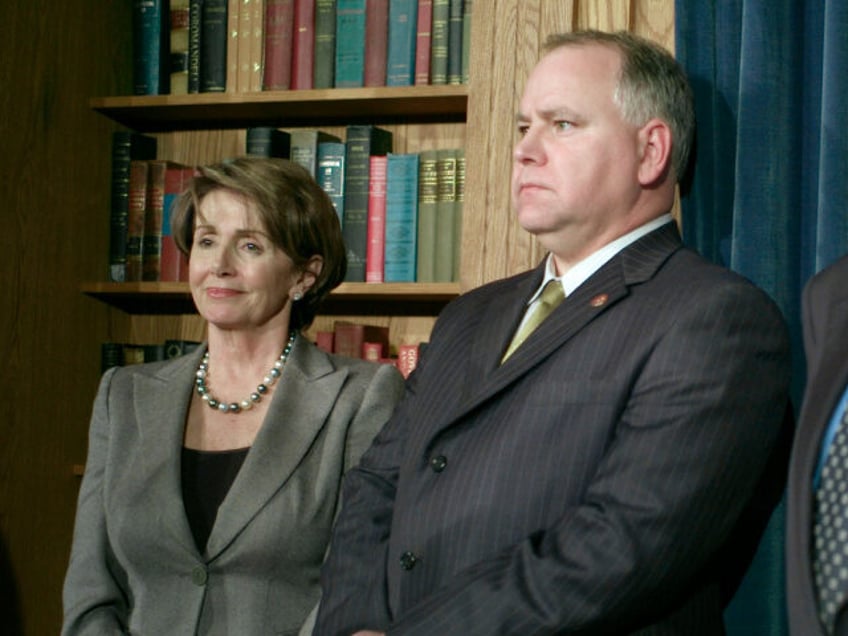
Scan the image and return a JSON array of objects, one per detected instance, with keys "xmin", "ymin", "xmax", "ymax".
[{"xmin": 246, "ymin": 124, "xmax": 465, "ymax": 283}]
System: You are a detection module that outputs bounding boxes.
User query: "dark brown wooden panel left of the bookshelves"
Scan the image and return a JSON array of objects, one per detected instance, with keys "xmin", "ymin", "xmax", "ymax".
[{"xmin": 0, "ymin": 0, "xmax": 131, "ymax": 635}]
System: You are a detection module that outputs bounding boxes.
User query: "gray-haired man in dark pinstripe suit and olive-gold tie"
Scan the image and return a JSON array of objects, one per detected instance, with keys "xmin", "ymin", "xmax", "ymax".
[{"xmin": 315, "ymin": 32, "xmax": 790, "ymax": 636}]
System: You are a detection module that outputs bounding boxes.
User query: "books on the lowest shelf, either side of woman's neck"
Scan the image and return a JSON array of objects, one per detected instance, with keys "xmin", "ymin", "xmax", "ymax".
[{"xmin": 100, "ymin": 328, "xmax": 424, "ymax": 377}]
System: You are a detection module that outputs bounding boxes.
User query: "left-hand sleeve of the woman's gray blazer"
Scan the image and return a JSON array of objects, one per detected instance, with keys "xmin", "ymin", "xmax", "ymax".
[{"xmin": 62, "ymin": 368, "xmax": 127, "ymax": 636}]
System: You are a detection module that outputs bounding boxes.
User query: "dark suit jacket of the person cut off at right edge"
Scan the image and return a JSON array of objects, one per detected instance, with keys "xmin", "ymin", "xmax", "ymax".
[{"xmin": 786, "ymin": 256, "xmax": 848, "ymax": 636}]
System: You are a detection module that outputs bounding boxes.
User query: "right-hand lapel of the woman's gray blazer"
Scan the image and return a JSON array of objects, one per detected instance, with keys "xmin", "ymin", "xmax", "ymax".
[{"xmin": 206, "ymin": 336, "xmax": 348, "ymax": 559}]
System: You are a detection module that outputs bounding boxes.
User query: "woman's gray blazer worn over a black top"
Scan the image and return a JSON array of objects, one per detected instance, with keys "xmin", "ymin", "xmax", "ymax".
[{"xmin": 62, "ymin": 336, "xmax": 403, "ymax": 636}]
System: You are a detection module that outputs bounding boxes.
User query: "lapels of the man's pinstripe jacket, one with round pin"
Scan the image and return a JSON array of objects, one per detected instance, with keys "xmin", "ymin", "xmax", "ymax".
[{"xmin": 452, "ymin": 223, "xmax": 681, "ymax": 428}]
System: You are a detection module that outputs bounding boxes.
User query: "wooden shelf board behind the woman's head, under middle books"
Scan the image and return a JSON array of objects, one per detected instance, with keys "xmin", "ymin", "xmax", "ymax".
[{"xmin": 81, "ymin": 282, "xmax": 460, "ymax": 316}]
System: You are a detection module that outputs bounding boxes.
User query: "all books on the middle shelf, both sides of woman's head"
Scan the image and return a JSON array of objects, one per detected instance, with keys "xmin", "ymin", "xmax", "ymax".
[{"xmin": 109, "ymin": 124, "xmax": 465, "ymax": 283}]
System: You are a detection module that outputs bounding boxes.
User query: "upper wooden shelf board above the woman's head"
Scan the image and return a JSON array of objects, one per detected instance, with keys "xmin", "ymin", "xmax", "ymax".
[{"xmin": 89, "ymin": 85, "xmax": 468, "ymax": 132}]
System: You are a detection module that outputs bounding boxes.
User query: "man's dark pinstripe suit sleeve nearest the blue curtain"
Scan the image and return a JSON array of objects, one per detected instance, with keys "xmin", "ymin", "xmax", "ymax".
[{"xmin": 388, "ymin": 285, "xmax": 789, "ymax": 636}]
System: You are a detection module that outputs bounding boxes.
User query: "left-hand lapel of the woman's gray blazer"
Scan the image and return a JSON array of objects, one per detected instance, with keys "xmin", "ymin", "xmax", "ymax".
[{"xmin": 133, "ymin": 347, "xmax": 206, "ymax": 554}]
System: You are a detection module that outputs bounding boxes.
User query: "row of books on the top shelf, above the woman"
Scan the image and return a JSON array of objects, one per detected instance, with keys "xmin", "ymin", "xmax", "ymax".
[{"xmin": 132, "ymin": 0, "xmax": 472, "ymax": 95}]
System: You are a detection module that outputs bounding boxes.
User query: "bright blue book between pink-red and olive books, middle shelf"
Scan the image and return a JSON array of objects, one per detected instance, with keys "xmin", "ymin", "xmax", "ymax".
[{"xmin": 383, "ymin": 154, "xmax": 418, "ymax": 283}]
